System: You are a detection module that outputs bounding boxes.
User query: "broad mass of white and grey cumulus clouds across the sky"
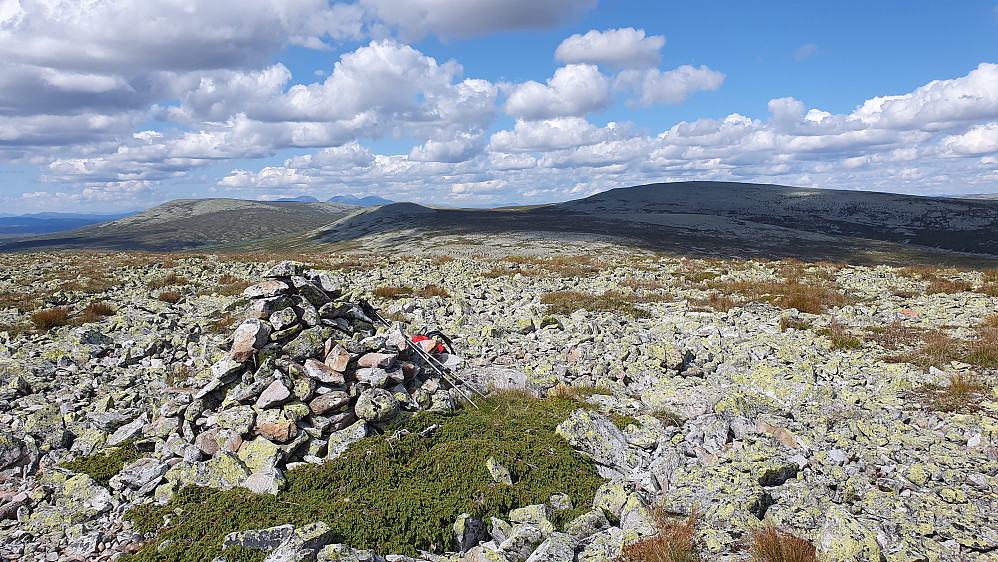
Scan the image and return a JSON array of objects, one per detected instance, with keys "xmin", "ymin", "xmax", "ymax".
[{"xmin": 0, "ymin": 4, "xmax": 998, "ymax": 211}]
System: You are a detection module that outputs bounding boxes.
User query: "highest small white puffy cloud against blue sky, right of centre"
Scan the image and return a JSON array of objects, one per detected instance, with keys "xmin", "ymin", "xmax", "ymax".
[{"xmin": 554, "ymin": 27, "xmax": 665, "ymax": 68}]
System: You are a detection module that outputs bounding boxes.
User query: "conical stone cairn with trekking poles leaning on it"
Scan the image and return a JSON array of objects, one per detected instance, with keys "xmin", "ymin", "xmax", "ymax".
[{"xmin": 150, "ymin": 262, "xmax": 460, "ymax": 496}]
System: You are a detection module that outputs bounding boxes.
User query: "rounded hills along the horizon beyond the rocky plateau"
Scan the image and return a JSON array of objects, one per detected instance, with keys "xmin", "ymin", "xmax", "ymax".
[{"xmin": 0, "ymin": 182, "xmax": 998, "ymax": 267}]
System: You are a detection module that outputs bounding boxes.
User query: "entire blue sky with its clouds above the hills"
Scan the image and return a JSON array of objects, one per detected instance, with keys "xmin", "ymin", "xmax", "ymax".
[{"xmin": 0, "ymin": 0, "xmax": 998, "ymax": 214}]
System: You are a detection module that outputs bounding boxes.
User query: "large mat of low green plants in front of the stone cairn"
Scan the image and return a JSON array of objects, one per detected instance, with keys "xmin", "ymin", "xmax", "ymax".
[{"xmin": 126, "ymin": 393, "xmax": 603, "ymax": 562}]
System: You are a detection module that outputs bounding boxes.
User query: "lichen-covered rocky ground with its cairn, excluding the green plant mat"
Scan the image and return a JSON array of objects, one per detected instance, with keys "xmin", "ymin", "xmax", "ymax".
[{"xmin": 0, "ymin": 252, "xmax": 998, "ymax": 562}]
